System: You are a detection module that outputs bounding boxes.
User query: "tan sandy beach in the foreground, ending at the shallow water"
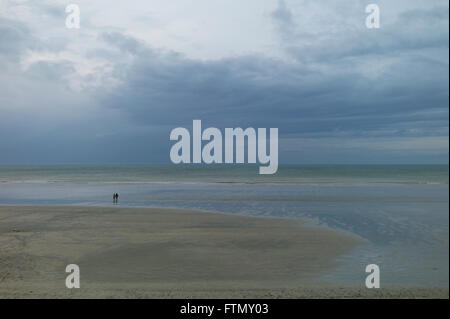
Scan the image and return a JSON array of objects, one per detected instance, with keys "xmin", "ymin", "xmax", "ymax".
[{"xmin": 0, "ymin": 206, "xmax": 448, "ymax": 298}]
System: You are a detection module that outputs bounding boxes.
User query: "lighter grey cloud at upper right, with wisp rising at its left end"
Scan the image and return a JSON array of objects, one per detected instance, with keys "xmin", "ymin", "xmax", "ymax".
[{"xmin": 272, "ymin": 1, "xmax": 449, "ymax": 63}]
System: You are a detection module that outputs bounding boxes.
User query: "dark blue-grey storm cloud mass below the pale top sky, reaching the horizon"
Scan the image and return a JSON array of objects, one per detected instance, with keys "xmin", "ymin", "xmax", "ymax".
[{"xmin": 0, "ymin": 1, "xmax": 449, "ymax": 163}]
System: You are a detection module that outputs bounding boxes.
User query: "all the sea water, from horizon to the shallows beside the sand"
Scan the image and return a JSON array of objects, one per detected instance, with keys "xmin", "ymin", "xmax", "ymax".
[{"xmin": 0, "ymin": 165, "xmax": 449, "ymax": 287}]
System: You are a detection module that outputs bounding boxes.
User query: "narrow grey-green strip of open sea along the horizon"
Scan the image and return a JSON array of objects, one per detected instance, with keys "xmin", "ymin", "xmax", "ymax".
[{"xmin": 0, "ymin": 165, "xmax": 449, "ymax": 185}]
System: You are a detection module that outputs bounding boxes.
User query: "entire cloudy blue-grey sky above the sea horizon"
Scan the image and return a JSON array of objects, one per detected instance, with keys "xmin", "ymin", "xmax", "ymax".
[{"xmin": 0, "ymin": 0, "xmax": 449, "ymax": 164}]
